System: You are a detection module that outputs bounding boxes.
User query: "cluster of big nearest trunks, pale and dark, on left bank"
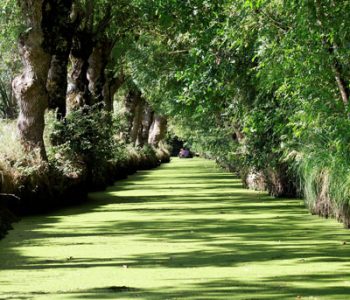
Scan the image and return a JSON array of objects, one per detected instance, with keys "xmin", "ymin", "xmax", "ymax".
[{"xmin": 12, "ymin": 0, "xmax": 124, "ymax": 160}]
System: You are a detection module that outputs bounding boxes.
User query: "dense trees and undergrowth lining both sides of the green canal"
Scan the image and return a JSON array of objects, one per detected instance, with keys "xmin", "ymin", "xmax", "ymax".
[{"xmin": 0, "ymin": 0, "xmax": 350, "ymax": 226}]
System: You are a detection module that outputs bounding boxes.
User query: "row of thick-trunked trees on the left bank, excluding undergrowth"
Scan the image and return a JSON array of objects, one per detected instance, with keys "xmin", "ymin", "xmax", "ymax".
[{"xmin": 0, "ymin": 0, "xmax": 164, "ymax": 160}]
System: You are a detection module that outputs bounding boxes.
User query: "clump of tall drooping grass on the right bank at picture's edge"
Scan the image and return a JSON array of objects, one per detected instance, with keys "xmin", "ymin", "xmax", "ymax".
[{"xmin": 295, "ymin": 118, "xmax": 350, "ymax": 227}]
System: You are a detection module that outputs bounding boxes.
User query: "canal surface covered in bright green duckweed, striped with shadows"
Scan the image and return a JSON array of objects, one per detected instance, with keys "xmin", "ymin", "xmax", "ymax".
[{"xmin": 0, "ymin": 159, "xmax": 350, "ymax": 299}]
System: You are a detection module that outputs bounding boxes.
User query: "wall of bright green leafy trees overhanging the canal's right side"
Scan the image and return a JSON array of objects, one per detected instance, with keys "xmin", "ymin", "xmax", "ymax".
[{"xmin": 123, "ymin": 0, "xmax": 350, "ymax": 224}]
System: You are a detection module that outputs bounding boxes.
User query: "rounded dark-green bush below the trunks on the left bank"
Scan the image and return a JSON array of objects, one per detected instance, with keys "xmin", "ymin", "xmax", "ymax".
[{"xmin": 49, "ymin": 105, "xmax": 121, "ymax": 187}]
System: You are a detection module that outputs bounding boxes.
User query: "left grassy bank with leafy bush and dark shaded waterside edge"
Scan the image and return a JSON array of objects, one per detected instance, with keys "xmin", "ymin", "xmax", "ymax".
[{"xmin": 0, "ymin": 116, "xmax": 170, "ymax": 237}]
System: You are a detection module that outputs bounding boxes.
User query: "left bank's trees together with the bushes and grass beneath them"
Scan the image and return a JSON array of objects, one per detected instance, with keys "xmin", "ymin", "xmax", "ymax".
[{"xmin": 0, "ymin": 0, "xmax": 169, "ymax": 206}]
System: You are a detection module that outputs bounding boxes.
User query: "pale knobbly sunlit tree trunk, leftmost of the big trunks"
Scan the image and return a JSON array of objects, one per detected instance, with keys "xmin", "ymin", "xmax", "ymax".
[{"xmin": 12, "ymin": 0, "xmax": 51, "ymax": 160}]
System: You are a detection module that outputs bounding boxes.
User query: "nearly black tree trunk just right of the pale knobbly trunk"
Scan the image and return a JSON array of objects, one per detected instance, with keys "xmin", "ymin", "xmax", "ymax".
[{"xmin": 46, "ymin": 0, "xmax": 75, "ymax": 119}]
